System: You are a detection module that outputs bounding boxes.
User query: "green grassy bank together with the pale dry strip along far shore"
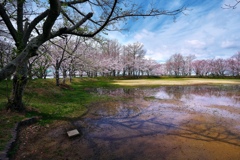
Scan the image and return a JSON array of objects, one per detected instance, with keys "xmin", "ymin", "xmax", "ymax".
[{"xmin": 0, "ymin": 78, "xmax": 240, "ymax": 151}]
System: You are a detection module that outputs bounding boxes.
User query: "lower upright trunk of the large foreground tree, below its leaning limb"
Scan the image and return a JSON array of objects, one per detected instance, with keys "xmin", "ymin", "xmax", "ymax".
[{"xmin": 7, "ymin": 62, "xmax": 28, "ymax": 111}]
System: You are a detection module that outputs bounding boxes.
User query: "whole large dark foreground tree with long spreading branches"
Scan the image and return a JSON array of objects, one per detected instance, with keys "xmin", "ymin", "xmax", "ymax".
[{"xmin": 0, "ymin": 0, "xmax": 184, "ymax": 110}]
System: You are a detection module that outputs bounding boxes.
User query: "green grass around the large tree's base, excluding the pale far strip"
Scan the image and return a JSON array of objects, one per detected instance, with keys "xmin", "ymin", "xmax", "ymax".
[{"xmin": 0, "ymin": 78, "xmax": 118, "ymax": 151}]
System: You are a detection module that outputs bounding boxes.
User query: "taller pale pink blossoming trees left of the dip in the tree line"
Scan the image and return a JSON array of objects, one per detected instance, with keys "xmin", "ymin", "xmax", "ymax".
[{"xmin": 0, "ymin": 36, "xmax": 161, "ymax": 85}]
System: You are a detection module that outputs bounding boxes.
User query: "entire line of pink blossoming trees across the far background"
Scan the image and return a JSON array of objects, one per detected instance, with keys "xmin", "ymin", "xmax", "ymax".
[{"xmin": 0, "ymin": 36, "xmax": 240, "ymax": 85}]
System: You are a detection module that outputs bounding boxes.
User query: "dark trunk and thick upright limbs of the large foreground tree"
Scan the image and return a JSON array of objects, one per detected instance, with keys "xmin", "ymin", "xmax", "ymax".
[{"xmin": 0, "ymin": 0, "xmax": 61, "ymax": 111}]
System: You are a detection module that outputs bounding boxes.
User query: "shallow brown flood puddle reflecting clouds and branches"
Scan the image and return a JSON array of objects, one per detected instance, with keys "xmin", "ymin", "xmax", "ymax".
[{"xmin": 73, "ymin": 86, "xmax": 240, "ymax": 160}]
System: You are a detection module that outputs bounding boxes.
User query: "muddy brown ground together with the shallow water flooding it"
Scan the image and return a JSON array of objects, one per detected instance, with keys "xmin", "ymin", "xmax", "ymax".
[{"xmin": 14, "ymin": 88, "xmax": 240, "ymax": 160}]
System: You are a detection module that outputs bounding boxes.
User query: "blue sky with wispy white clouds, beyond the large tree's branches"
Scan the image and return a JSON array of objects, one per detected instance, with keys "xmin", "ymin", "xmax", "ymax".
[{"xmin": 108, "ymin": 0, "xmax": 240, "ymax": 63}]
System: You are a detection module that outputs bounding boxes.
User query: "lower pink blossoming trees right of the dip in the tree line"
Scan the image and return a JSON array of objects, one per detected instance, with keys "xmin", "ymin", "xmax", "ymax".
[{"xmin": 162, "ymin": 52, "xmax": 240, "ymax": 77}]
